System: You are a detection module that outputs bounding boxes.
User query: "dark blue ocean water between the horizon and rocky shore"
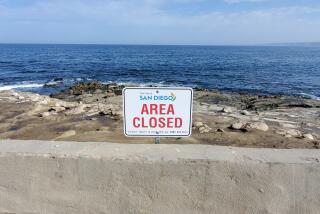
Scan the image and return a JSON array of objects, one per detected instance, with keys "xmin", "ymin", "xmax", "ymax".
[{"xmin": 0, "ymin": 44, "xmax": 320, "ymax": 99}]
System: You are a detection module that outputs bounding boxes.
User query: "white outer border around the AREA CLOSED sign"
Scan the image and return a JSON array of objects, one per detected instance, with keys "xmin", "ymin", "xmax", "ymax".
[{"xmin": 122, "ymin": 87, "xmax": 193, "ymax": 137}]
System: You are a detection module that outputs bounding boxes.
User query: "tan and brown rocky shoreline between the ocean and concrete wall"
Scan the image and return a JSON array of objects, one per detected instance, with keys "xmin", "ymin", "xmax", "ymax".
[{"xmin": 0, "ymin": 82, "xmax": 320, "ymax": 149}]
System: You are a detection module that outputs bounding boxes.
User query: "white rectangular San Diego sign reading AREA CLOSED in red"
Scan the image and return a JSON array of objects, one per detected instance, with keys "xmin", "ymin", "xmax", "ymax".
[{"xmin": 122, "ymin": 87, "xmax": 193, "ymax": 137}]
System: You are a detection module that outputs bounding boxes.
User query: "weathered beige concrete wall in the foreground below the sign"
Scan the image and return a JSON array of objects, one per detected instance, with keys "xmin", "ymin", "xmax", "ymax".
[{"xmin": 0, "ymin": 140, "xmax": 320, "ymax": 214}]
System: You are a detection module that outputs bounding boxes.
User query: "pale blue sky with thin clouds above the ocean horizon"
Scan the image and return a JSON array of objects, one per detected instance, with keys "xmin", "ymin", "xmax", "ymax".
[{"xmin": 0, "ymin": 0, "xmax": 320, "ymax": 45}]
